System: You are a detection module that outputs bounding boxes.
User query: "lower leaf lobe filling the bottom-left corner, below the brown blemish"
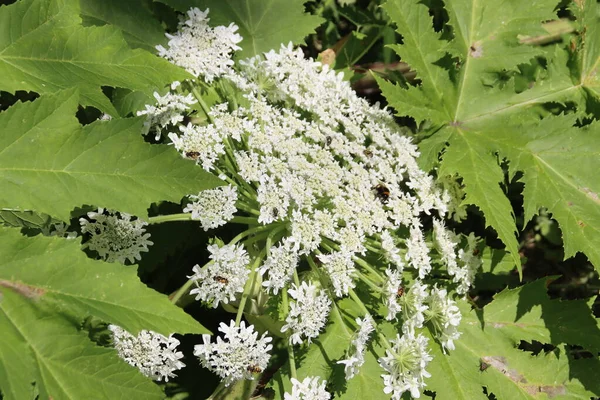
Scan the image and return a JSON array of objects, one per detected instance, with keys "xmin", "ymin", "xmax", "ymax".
[{"xmin": 0, "ymin": 288, "xmax": 164, "ymax": 400}]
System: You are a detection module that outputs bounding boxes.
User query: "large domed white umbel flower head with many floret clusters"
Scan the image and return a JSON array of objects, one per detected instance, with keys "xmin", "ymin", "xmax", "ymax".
[{"xmin": 148, "ymin": 9, "xmax": 486, "ymax": 400}]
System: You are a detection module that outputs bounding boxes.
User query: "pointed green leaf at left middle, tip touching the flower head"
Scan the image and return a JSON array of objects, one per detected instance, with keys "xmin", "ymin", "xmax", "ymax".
[{"xmin": 0, "ymin": 91, "xmax": 220, "ymax": 220}]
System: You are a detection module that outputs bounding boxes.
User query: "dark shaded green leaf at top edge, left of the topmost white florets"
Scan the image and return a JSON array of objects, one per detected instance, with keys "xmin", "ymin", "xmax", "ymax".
[{"xmin": 79, "ymin": 0, "xmax": 167, "ymax": 54}]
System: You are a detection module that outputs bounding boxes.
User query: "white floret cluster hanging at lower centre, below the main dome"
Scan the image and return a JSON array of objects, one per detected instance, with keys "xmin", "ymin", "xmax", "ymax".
[{"xmin": 281, "ymin": 282, "xmax": 331, "ymax": 344}]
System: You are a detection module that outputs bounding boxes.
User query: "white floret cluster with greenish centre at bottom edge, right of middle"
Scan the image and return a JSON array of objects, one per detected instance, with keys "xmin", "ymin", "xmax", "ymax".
[{"xmin": 379, "ymin": 333, "xmax": 433, "ymax": 400}]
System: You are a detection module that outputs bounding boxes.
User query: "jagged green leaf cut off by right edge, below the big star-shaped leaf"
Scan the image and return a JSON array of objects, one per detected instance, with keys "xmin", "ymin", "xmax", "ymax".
[{"xmin": 490, "ymin": 116, "xmax": 600, "ymax": 268}]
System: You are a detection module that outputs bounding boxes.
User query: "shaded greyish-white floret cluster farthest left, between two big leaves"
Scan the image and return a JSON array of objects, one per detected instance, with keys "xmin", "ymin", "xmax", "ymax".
[{"xmin": 79, "ymin": 208, "xmax": 153, "ymax": 264}]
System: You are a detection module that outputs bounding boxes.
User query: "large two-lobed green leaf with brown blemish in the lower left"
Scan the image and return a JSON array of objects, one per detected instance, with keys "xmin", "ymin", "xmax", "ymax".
[{"xmin": 0, "ymin": 227, "xmax": 208, "ymax": 400}]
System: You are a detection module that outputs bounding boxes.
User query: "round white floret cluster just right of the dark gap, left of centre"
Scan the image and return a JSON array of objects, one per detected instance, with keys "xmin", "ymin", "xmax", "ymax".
[{"xmin": 188, "ymin": 244, "xmax": 250, "ymax": 308}]
